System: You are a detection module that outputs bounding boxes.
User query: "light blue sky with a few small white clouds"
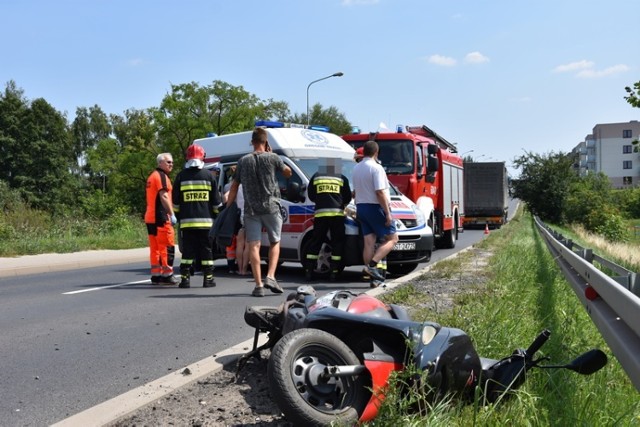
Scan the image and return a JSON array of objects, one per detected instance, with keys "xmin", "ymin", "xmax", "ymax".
[{"xmin": 0, "ymin": 0, "xmax": 640, "ymax": 174}]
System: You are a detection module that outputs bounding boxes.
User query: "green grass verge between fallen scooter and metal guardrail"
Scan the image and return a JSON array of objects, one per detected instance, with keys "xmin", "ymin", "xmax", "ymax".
[{"xmin": 374, "ymin": 215, "xmax": 640, "ymax": 426}]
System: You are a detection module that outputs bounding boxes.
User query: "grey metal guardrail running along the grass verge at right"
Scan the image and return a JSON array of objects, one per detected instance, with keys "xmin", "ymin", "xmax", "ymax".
[{"xmin": 535, "ymin": 217, "xmax": 640, "ymax": 391}]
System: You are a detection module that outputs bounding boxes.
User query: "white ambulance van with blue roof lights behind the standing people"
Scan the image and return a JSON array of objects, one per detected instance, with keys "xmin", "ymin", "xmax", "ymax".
[{"xmin": 194, "ymin": 122, "xmax": 433, "ymax": 274}]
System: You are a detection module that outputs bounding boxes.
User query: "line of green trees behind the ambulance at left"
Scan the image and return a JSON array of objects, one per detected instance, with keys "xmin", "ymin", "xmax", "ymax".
[{"xmin": 0, "ymin": 80, "xmax": 351, "ymax": 218}]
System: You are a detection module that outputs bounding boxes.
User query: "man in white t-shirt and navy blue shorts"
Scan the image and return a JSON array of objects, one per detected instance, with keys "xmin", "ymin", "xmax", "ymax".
[{"xmin": 353, "ymin": 141, "xmax": 398, "ymax": 286}]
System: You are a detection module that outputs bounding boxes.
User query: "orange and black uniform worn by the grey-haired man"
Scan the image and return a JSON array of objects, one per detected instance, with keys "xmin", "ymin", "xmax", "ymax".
[{"xmin": 144, "ymin": 168, "xmax": 175, "ymax": 285}]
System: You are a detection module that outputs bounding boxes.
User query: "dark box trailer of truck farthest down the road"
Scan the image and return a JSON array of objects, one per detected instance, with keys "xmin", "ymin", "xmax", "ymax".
[{"xmin": 463, "ymin": 162, "xmax": 509, "ymax": 228}]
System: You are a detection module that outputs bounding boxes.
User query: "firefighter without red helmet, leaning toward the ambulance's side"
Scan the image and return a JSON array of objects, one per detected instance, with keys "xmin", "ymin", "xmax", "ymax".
[{"xmin": 305, "ymin": 159, "xmax": 351, "ymax": 281}]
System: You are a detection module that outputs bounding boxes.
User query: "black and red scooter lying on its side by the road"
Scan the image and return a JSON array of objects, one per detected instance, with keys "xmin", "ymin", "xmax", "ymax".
[{"xmin": 238, "ymin": 286, "xmax": 607, "ymax": 426}]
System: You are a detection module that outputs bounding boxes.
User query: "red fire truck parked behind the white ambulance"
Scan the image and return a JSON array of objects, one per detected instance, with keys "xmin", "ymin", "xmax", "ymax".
[{"xmin": 342, "ymin": 125, "xmax": 464, "ymax": 248}]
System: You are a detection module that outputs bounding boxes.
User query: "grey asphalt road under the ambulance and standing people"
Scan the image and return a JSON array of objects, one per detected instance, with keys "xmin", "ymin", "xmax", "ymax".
[{"xmin": 0, "ymin": 219, "xmax": 504, "ymax": 426}]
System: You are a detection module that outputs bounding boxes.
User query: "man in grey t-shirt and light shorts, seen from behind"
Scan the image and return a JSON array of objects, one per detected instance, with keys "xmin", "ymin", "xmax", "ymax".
[{"xmin": 227, "ymin": 128, "xmax": 291, "ymax": 297}]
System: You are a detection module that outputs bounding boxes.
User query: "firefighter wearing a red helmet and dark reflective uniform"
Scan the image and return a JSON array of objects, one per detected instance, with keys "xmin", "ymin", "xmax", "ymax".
[{"xmin": 173, "ymin": 144, "xmax": 221, "ymax": 288}]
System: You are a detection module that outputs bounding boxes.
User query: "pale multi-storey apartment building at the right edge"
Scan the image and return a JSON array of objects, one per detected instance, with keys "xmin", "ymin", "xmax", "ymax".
[{"xmin": 573, "ymin": 120, "xmax": 640, "ymax": 188}]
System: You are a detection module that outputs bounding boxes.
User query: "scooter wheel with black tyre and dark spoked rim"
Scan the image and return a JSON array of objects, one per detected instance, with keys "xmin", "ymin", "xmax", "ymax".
[{"xmin": 267, "ymin": 328, "xmax": 371, "ymax": 426}]
